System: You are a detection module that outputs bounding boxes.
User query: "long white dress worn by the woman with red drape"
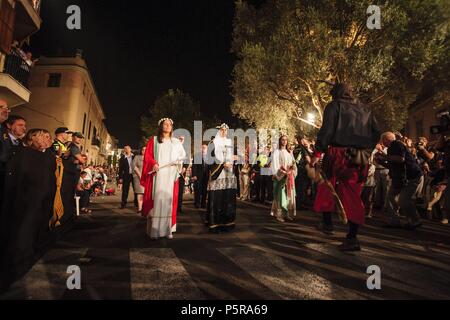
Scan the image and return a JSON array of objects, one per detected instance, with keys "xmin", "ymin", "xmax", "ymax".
[{"xmin": 147, "ymin": 138, "xmax": 186, "ymax": 238}]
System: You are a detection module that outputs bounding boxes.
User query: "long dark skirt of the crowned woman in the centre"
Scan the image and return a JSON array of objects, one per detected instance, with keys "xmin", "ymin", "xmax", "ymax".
[{"xmin": 206, "ymin": 189, "xmax": 236, "ymax": 231}]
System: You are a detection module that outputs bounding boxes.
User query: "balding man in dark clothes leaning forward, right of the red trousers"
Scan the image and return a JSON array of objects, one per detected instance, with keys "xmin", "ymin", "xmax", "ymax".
[{"xmin": 377, "ymin": 132, "xmax": 423, "ymax": 230}]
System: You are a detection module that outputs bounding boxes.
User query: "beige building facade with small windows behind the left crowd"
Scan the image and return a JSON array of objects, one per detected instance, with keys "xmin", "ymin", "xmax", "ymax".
[{"xmin": 13, "ymin": 57, "xmax": 108, "ymax": 164}]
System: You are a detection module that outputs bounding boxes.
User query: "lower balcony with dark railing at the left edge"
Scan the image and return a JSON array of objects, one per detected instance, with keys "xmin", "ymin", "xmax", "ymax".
[{"xmin": 0, "ymin": 50, "xmax": 31, "ymax": 107}]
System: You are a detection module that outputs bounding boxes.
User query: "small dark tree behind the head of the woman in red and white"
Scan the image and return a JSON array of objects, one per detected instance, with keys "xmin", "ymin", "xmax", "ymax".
[{"xmin": 141, "ymin": 89, "xmax": 200, "ymax": 139}]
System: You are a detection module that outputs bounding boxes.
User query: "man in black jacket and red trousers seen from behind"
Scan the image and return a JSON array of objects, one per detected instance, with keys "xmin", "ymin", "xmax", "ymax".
[{"xmin": 312, "ymin": 83, "xmax": 380, "ymax": 251}]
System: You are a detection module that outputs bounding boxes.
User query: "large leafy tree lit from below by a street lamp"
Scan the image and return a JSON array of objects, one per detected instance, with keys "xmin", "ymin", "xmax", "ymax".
[{"xmin": 232, "ymin": 0, "xmax": 449, "ymax": 133}]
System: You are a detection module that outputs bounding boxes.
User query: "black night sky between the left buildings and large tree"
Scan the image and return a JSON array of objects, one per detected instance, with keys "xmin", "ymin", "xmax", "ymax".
[{"xmin": 31, "ymin": 0, "xmax": 239, "ymax": 146}]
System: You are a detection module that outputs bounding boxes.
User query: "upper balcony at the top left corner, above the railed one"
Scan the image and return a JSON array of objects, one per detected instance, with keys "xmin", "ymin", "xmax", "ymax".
[{"xmin": 14, "ymin": 0, "xmax": 42, "ymax": 41}]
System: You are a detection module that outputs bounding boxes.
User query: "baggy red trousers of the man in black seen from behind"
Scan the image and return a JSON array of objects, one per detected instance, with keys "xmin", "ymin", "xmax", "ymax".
[{"xmin": 314, "ymin": 147, "xmax": 367, "ymax": 225}]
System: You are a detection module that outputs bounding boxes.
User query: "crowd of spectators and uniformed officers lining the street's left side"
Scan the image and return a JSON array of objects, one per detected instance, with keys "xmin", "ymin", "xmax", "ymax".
[{"xmin": 0, "ymin": 100, "xmax": 114, "ymax": 288}]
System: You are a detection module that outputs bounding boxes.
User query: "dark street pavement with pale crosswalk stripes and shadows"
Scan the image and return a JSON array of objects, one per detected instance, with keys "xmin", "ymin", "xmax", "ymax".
[{"xmin": 0, "ymin": 192, "xmax": 450, "ymax": 299}]
